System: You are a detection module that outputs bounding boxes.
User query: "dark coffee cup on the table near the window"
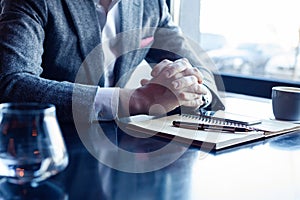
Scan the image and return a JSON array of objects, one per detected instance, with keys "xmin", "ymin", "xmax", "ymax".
[{"xmin": 272, "ymin": 86, "xmax": 300, "ymax": 121}]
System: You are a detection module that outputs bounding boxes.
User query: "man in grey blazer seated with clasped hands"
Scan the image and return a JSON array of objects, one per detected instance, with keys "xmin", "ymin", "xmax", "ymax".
[{"xmin": 0, "ymin": 0, "xmax": 223, "ymax": 122}]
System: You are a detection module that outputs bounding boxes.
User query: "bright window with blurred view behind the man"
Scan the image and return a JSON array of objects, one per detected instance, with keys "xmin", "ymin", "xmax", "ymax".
[{"xmin": 170, "ymin": 0, "xmax": 300, "ymax": 97}]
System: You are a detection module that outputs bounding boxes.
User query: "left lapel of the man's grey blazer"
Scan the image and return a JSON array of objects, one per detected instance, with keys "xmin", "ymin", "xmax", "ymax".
[{"xmin": 65, "ymin": 0, "xmax": 103, "ymax": 85}]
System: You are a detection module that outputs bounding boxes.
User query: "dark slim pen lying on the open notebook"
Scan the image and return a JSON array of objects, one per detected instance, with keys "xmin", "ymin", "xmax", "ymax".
[{"xmin": 173, "ymin": 121, "xmax": 256, "ymax": 132}]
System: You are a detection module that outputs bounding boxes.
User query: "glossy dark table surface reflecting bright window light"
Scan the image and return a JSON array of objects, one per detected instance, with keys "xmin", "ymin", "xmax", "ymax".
[{"xmin": 2, "ymin": 95, "xmax": 300, "ymax": 200}]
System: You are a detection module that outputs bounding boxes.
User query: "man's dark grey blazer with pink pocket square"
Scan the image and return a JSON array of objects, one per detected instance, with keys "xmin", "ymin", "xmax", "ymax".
[{"xmin": 0, "ymin": 0, "xmax": 223, "ymax": 120}]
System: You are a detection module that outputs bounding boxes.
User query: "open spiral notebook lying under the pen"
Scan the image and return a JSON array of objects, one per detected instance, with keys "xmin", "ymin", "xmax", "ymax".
[{"xmin": 127, "ymin": 114, "xmax": 300, "ymax": 150}]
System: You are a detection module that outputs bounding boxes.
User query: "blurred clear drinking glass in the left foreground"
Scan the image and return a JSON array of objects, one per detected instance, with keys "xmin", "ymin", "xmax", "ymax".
[{"xmin": 0, "ymin": 103, "xmax": 68, "ymax": 185}]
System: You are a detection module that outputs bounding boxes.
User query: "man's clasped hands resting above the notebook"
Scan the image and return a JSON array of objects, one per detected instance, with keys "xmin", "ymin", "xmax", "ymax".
[{"xmin": 120, "ymin": 58, "xmax": 207, "ymax": 115}]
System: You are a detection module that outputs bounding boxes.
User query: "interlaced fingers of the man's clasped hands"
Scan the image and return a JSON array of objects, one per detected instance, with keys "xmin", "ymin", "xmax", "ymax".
[{"xmin": 147, "ymin": 58, "xmax": 207, "ymax": 108}]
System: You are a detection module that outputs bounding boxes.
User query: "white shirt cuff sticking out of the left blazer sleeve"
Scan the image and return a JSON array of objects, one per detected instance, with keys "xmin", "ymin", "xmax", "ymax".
[{"xmin": 94, "ymin": 87, "xmax": 120, "ymax": 121}]
